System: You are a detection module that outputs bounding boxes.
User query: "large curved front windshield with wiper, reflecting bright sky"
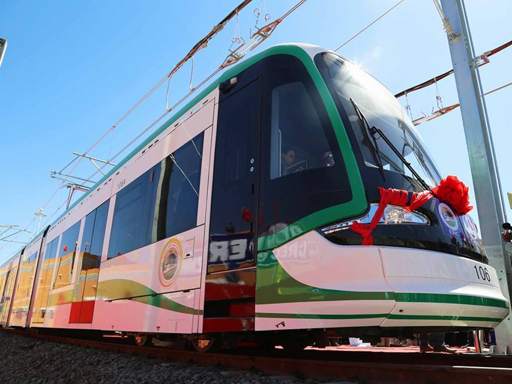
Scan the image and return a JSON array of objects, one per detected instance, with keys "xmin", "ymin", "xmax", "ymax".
[{"xmin": 316, "ymin": 53, "xmax": 440, "ymax": 186}]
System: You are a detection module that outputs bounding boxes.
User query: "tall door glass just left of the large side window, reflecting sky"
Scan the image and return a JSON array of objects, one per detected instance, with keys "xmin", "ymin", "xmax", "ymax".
[{"xmin": 82, "ymin": 200, "xmax": 110, "ymax": 271}]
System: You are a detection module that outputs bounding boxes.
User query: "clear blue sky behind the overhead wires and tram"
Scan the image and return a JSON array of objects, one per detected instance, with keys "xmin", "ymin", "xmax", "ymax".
[{"xmin": 0, "ymin": 0, "xmax": 512, "ymax": 262}]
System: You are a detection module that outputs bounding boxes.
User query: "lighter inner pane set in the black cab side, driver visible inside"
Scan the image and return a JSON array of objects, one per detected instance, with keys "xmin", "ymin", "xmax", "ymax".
[{"xmin": 270, "ymin": 81, "xmax": 335, "ymax": 180}]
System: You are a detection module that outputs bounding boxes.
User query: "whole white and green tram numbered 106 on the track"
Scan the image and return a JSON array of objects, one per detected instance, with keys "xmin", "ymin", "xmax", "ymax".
[{"xmin": 0, "ymin": 44, "xmax": 509, "ymax": 350}]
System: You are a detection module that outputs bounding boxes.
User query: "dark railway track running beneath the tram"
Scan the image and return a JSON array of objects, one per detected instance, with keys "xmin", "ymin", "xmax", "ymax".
[{"xmin": 3, "ymin": 330, "xmax": 512, "ymax": 384}]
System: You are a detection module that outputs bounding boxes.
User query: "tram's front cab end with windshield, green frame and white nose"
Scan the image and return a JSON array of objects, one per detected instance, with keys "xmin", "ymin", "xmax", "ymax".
[{"xmin": 255, "ymin": 47, "xmax": 509, "ymax": 335}]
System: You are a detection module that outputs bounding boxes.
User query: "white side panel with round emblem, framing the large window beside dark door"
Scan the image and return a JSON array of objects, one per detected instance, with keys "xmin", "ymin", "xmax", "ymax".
[{"xmin": 94, "ymin": 94, "xmax": 215, "ymax": 333}]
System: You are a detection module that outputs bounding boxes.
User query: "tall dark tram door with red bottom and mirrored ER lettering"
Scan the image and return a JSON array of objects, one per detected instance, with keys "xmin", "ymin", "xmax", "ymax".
[{"xmin": 203, "ymin": 72, "xmax": 261, "ymax": 332}]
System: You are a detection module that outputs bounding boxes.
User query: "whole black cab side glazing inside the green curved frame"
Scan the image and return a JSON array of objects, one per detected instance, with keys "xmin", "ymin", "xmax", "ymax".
[{"xmin": 258, "ymin": 55, "xmax": 352, "ymax": 235}]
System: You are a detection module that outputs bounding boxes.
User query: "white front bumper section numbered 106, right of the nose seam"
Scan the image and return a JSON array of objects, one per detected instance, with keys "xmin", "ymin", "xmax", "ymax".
[{"xmin": 379, "ymin": 247, "xmax": 508, "ymax": 327}]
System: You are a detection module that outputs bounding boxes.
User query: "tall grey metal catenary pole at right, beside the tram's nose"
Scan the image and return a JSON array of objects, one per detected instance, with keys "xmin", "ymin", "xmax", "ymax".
[{"xmin": 441, "ymin": 0, "xmax": 512, "ymax": 353}]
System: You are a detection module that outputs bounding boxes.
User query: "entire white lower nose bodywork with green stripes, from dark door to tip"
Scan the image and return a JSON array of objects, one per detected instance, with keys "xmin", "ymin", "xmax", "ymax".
[{"xmin": 256, "ymin": 231, "xmax": 508, "ymax": 331}]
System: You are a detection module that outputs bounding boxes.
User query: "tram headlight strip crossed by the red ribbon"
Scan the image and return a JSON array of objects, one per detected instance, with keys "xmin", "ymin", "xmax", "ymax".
[{"xmin": 322, "ymin": 204, "xmax": 430, "ymax": 234}]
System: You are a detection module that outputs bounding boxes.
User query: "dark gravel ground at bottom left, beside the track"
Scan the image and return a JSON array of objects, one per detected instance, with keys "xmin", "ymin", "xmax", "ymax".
[{"xmin": 0, "ymin": 333, "xmax": 332, "ymax": 384}]
